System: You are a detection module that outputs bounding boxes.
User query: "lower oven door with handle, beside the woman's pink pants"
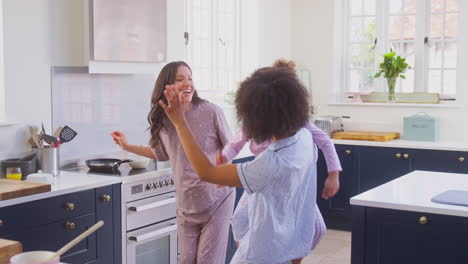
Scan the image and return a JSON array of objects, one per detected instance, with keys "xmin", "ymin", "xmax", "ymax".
[{"xmin": 127, "ymin": 218, "xmax": 177, "ymax": 264}]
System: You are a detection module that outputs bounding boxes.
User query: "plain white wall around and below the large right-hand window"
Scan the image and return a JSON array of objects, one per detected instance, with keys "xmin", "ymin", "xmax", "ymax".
[{"xmin": 291, "ymin": 0, "xmax": 468, "ymax": 141}]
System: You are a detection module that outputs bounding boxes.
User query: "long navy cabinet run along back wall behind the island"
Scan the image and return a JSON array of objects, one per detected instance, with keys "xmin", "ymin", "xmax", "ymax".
[{"xmin": 317, "ymin": 145, "xmax": 468, "ymax": 230}]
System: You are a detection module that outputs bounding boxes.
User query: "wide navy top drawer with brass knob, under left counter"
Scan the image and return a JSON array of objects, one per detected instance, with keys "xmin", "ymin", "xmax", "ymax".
[{"xmin": 0, "ymin": 189, "xmax": 96, "ymax": 235}]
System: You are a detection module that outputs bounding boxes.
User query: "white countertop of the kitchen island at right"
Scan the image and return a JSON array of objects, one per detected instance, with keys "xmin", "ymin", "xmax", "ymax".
[{"xmin": 350, "ymin": 171, "xmax": 468, "ymax": 217}]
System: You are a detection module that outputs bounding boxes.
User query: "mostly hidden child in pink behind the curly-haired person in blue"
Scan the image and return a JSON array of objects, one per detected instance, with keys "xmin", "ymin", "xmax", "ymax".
[{"xmin": 216, "ymin": 60, "xmax": 342, "ymax": 264}]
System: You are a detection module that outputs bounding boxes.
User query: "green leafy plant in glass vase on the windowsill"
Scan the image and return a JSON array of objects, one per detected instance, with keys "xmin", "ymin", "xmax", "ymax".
[{"xmin": 374, "ymin": 49, "xmax": 409, "ymax": 103}]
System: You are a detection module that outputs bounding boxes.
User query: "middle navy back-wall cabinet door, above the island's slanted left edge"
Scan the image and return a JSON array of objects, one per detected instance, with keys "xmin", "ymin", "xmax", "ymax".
[{"xmin": 354, "ymin": 147, "xmax": 412, "ymax": 193}]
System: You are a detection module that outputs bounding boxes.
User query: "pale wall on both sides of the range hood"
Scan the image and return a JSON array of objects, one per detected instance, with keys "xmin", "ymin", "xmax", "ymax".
[{"xmin": 0, "ymin": 0, "xmax": 185, "ymax": 159}]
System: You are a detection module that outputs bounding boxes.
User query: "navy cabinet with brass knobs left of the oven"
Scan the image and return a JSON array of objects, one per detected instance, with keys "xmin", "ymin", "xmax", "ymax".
[{"xmin": 0, "ymin": 184, "xmax": 122, "ymax": 264}]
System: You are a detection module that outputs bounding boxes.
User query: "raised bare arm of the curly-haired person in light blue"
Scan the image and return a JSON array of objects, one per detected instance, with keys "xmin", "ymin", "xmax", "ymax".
[{"xmin": 159, "ymin": 86, "xmax": 242, "ymax": 187}]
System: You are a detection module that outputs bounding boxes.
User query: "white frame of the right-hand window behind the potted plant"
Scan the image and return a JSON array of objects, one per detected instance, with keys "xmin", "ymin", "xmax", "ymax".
[{"xmin": 333, "ymin": 0, "xmax": 464, "ymax": 102}]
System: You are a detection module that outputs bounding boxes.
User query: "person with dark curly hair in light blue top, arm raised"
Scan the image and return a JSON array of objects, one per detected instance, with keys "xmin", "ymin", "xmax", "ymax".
[{"xmin": 160, "ymin": 63, "xmax": 317, "ymax": 264}]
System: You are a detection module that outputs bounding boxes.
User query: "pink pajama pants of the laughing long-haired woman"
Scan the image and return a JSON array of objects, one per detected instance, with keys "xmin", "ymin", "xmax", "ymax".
[{"xmin": 177, "ymin": 191, "xmax": 236, "ymax": 264}]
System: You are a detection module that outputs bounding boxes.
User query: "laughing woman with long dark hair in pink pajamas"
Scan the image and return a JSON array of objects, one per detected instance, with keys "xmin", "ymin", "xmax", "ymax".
[{"xmin": 111, "ymin": 61, "xmax": 235, "ymax": 264}]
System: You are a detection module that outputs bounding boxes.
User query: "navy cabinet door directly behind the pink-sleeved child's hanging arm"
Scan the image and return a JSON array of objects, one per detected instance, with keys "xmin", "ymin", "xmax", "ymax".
[{"xmin": 317, "ymin": 145, "xmax": 354, "ymax": 230}]
